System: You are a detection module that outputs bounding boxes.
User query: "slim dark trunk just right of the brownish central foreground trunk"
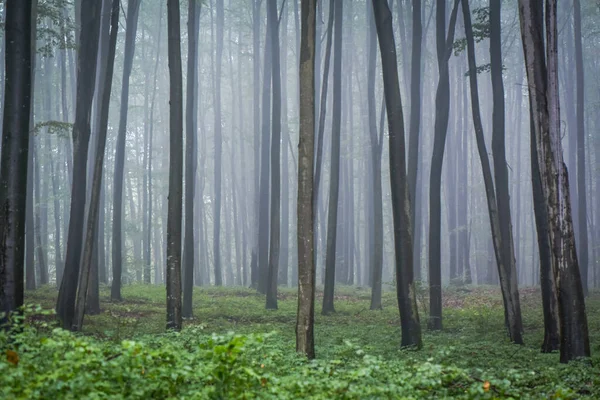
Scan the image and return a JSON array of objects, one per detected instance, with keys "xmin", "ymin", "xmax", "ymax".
[{"xmin": 322, "ymin": 0, "xmax": 344, "ymax": 315}]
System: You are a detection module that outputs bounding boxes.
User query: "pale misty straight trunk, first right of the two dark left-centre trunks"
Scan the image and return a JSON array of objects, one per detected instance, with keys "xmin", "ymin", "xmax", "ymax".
[{"xmin": 213, "ymin": 0, "xmax": 225, "ymax": 286}]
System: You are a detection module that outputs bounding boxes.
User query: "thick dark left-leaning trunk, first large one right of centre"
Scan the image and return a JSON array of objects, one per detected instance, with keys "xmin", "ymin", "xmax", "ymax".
[{"xmin": 373, "ymin": 0, "xmax": 422, "ymax": 348}]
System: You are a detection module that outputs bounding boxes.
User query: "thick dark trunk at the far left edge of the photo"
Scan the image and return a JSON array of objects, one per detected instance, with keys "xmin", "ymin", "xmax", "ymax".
[{"xmin": 0, "ymin": 0, "xmax": 32, "ymax": 320}]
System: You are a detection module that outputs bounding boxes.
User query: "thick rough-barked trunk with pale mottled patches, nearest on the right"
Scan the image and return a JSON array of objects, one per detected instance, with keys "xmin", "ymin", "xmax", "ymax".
[{"xmin": 519, "ymin": 0, "xmax": 590, "ymax": 363}]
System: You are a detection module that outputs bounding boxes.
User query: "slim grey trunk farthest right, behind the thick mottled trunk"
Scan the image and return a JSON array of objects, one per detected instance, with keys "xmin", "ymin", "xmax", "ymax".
[{"xmin": 572, "ymin": 0, "xmax": 589, "ymax": 295}]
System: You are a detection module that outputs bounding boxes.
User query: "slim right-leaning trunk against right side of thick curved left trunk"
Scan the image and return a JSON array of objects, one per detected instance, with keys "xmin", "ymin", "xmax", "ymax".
[{"xmin": 73, "ymin": 0, "xmax": 120, "ymax": 331}]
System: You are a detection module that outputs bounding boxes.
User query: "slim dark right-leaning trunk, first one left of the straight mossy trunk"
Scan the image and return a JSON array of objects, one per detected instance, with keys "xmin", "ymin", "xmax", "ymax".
[{"xmin": 110, "ymin": 0, "xmax": 141, "ymax": 301}]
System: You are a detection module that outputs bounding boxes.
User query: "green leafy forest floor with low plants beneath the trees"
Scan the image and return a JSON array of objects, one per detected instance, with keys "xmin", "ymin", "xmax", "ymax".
[{"xmin": 0, "ymin": 285, "xmax": 600, "ymax": 399}]
